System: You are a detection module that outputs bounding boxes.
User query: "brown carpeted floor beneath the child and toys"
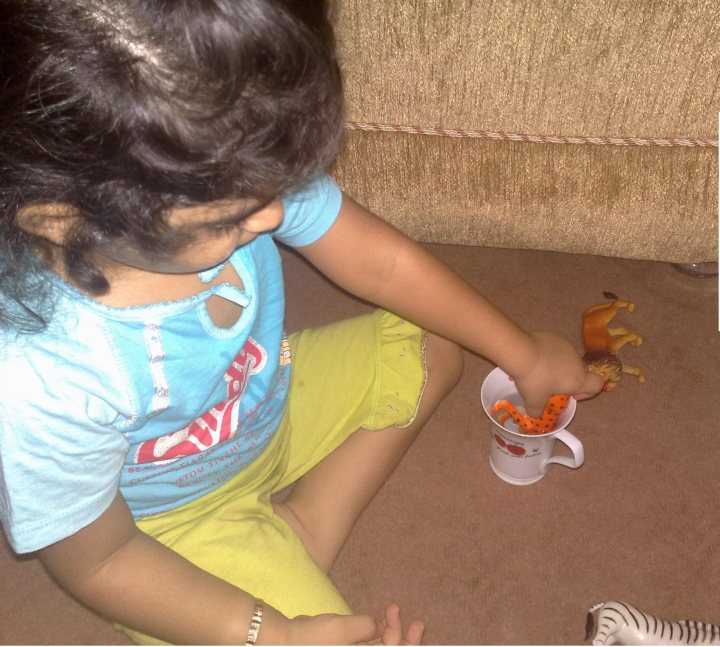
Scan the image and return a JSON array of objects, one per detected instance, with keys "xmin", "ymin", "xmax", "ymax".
[{"xmin": 0, "ymin": 245, "xmax": 720, "ymax": 645}]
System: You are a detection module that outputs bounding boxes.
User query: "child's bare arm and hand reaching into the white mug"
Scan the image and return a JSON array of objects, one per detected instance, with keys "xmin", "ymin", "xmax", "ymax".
[{"xmin": 299, "ymin": 196, "xmax": 602, "ymax": 415}]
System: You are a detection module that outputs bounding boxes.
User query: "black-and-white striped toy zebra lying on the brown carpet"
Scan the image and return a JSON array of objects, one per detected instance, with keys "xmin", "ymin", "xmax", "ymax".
[{"xmin": 585, "ymin": 600, "xmax": 720, "ymax": 645}]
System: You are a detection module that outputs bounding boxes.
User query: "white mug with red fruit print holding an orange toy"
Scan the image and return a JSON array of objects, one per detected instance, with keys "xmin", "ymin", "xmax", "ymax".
[{"xmin": 480, "ymin": 368, "xmax": 585, "ymax": 485}]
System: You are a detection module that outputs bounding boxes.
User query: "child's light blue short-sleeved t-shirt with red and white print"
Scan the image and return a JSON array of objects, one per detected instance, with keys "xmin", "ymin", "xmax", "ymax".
[{"xmin": 0, "ymin": 176, "xmax": 342, "ymax": 553}]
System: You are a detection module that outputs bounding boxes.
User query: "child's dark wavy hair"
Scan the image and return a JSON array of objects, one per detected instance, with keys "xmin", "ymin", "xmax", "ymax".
[{"xmin": 0, "ymin": 0, "xmax": 343, "ymax": 331}]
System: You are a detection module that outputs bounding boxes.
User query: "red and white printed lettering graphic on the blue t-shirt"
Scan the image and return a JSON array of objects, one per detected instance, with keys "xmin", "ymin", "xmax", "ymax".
[{"xmin": 134, "ymin": 337, "xmax": 267, "ymax": 465}]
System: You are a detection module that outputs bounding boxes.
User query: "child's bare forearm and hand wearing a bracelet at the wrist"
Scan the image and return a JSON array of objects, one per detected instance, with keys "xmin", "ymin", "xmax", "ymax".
[{"xmin": 40, "ymin": 494, "xmax": 378, "ymax": 645}]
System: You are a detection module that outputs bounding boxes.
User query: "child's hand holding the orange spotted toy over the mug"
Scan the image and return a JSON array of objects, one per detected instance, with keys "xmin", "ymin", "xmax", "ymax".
[{"xmin": 512, "ymin": 332, "xmax": 605, "ymax": 416}]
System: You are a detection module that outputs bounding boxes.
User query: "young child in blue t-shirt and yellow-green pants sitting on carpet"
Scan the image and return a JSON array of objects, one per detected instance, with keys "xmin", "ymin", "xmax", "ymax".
[{"xmin": 0, "ymin": 0, "xmax": 601, "ymax": 644}]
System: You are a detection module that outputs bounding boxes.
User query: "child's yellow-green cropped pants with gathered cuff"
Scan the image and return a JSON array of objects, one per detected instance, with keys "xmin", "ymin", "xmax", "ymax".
[{"xmin": 121, "ymin": 311, "xmax": 426, "ymax": 644}]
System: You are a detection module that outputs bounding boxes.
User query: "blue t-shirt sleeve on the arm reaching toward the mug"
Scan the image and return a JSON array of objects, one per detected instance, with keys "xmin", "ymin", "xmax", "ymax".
[{"xmin": 274, "ymin": 174, "xmax": 342, "ymax": 247}]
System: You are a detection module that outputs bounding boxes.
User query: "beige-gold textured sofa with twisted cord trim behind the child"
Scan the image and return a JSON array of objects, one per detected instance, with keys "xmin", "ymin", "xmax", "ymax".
[{"xmin": 334, "ymin": 0, "xmax": 720, "ymax": 262}]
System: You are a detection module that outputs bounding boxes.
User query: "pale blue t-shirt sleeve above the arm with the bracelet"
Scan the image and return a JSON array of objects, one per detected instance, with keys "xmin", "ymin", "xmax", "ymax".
[{"xmin": 0, "ymin": 346, "xmax": 128, "ymax": 553}]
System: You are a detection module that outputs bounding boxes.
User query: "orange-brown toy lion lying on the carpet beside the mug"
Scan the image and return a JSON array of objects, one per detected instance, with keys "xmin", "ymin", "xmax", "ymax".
[{"xmin": 582, "ymin": 292, "xmax": 645, "ymax": 391}]
